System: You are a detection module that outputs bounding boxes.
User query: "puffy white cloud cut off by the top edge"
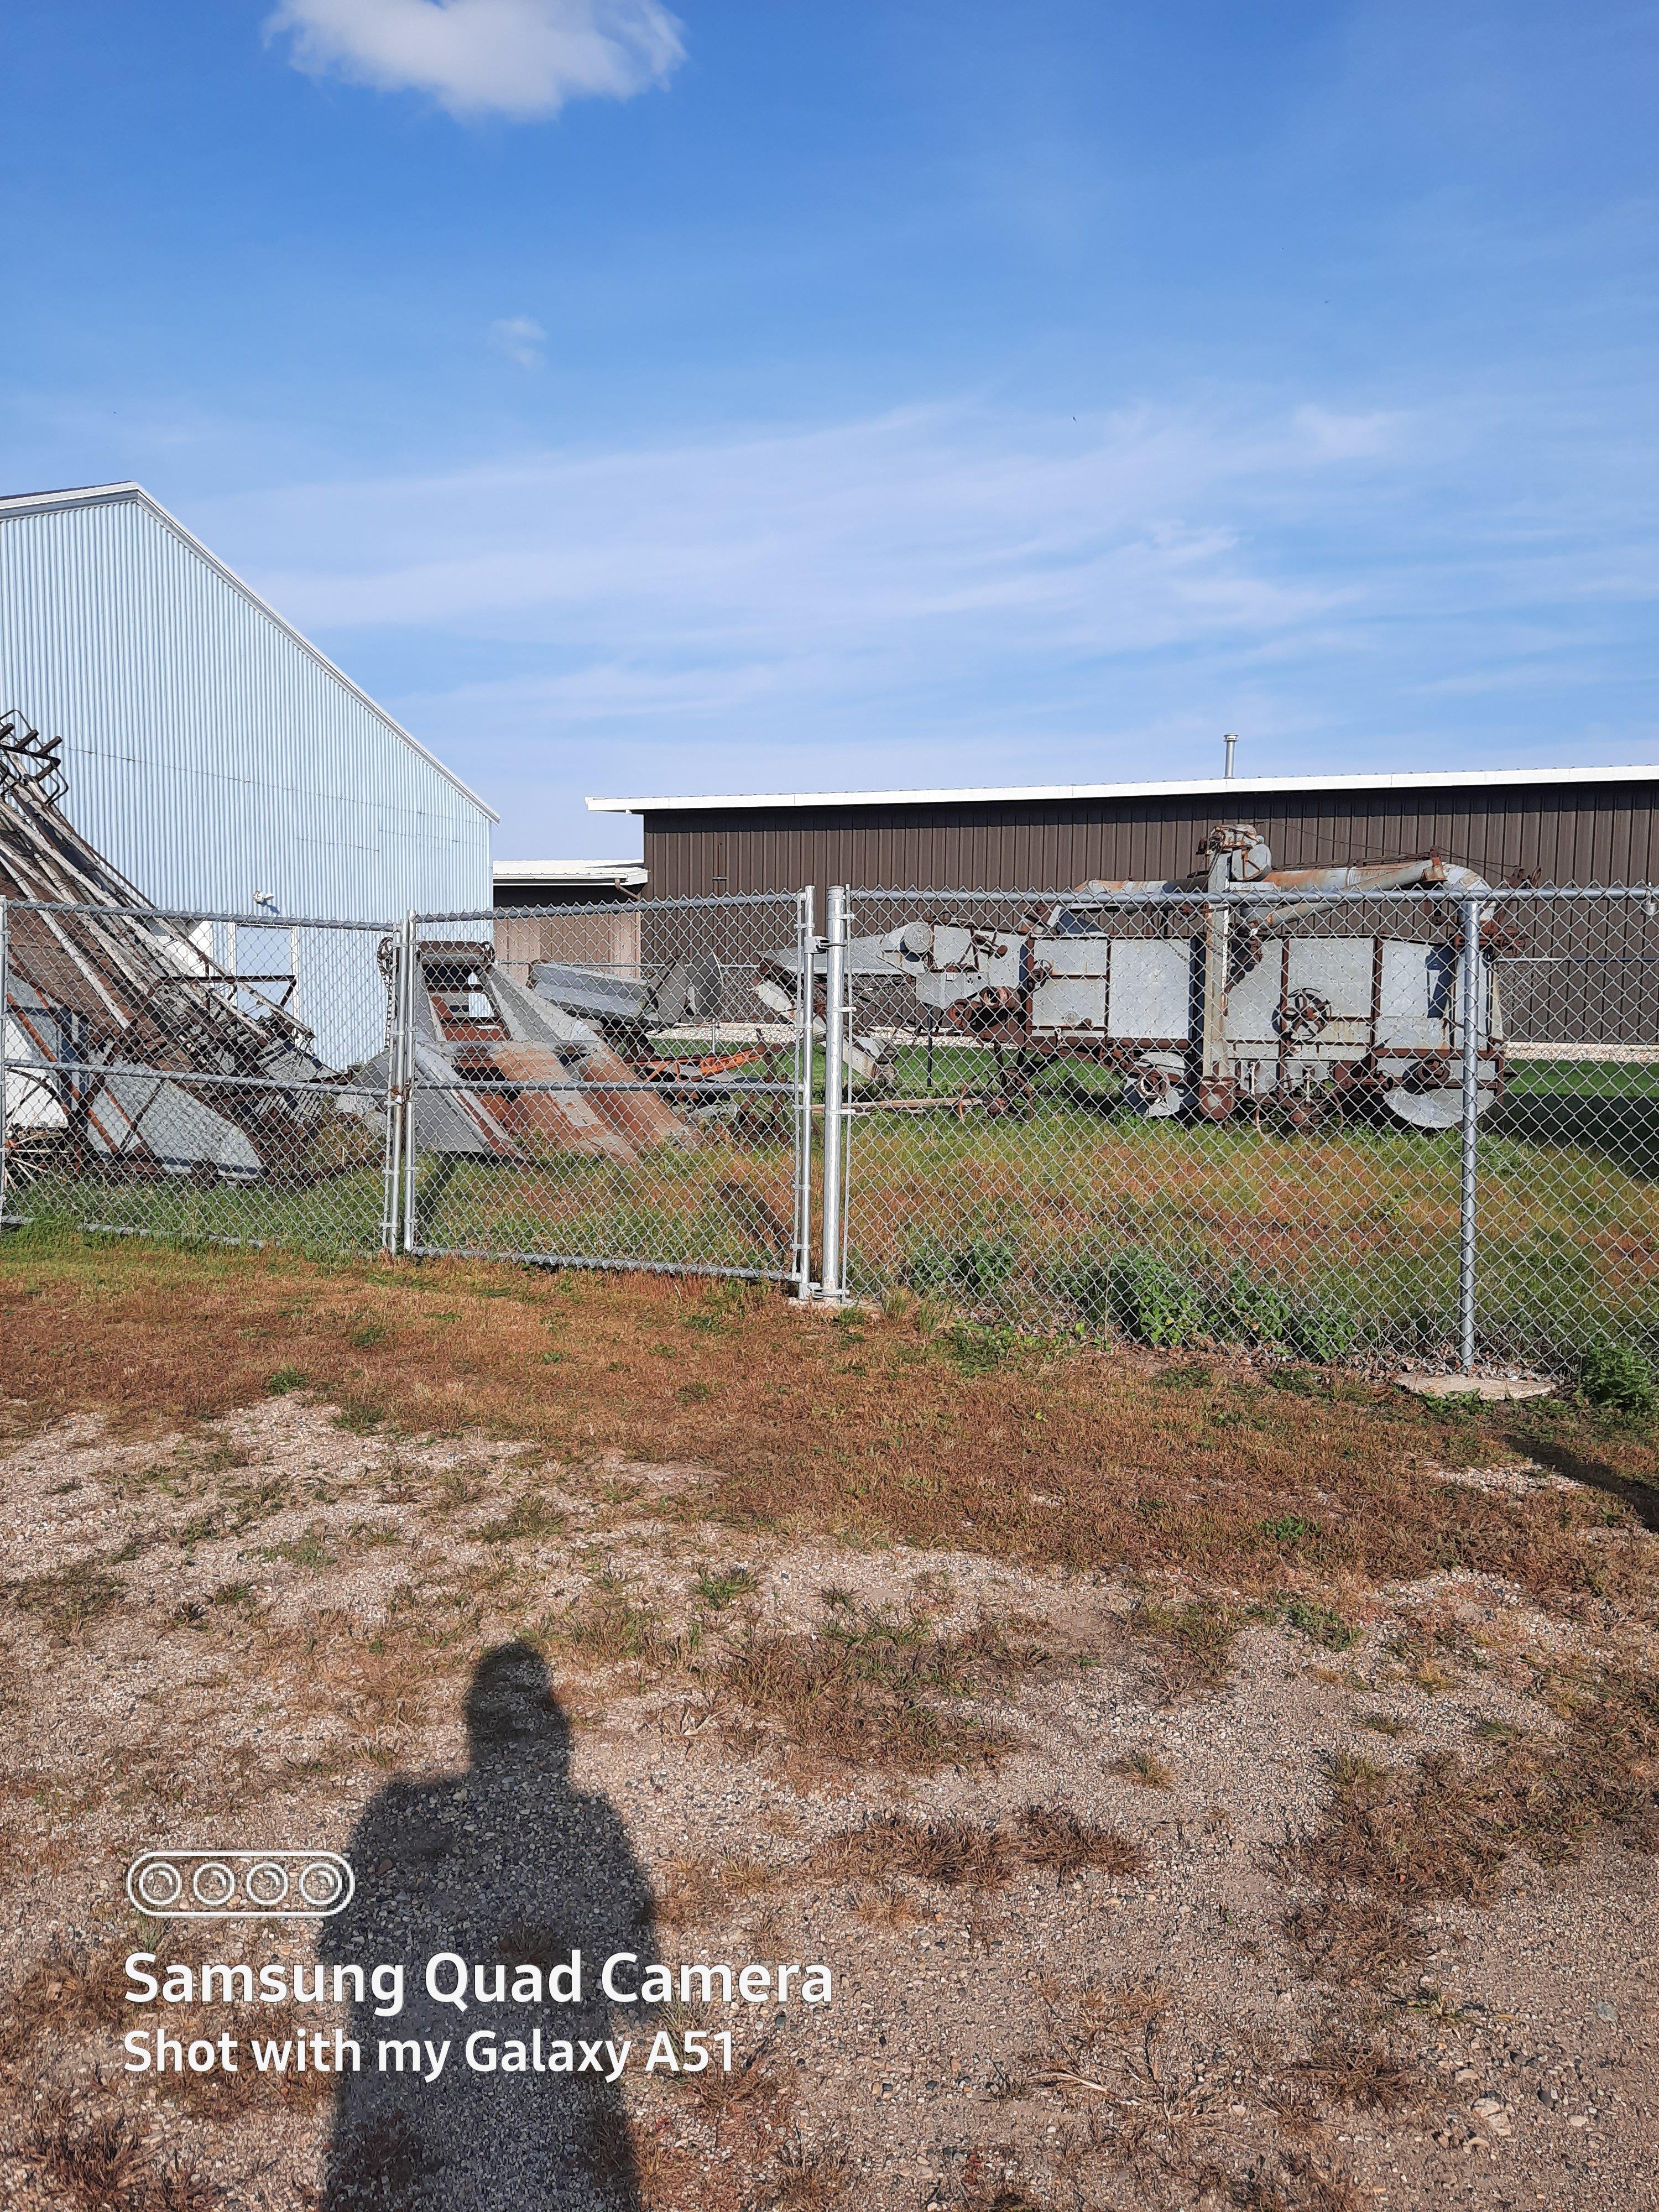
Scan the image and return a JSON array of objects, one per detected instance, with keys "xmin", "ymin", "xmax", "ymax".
[{"xmin": 265, "ymin": 0, "xmax": 686, "ymax": 122}]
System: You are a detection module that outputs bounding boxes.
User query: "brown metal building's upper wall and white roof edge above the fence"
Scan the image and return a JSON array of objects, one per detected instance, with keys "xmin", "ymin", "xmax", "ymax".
[{"xmin": 588, "ymin": 768, "xmax": 1659, "ymax": 898}]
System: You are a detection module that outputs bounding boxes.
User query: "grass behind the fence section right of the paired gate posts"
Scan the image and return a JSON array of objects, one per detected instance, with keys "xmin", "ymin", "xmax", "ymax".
[{"xmin": 847, "ymin": 1055, "xmax": 1659, "ymax": 1371}]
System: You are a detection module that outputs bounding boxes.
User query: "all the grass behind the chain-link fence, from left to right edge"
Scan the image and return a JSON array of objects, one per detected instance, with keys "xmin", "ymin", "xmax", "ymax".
[{"xmin": 11, "ymin": 1046, "xmax": 1659, "ymax": 1374}]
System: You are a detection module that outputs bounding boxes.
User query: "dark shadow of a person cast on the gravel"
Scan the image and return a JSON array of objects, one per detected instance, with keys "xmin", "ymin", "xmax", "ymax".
[{"xmin": 319, "ymin": 1644, "xmax": 655, "ymax": 2212}]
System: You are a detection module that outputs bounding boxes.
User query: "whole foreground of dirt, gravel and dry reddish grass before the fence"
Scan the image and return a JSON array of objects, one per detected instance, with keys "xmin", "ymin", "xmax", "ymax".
[{"xmin": 0, "ymin": 1254, "xmax": 1659, "ymax": 2212}]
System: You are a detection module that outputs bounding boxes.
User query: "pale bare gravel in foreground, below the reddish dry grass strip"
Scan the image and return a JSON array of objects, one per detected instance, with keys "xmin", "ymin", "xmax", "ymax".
[{"xmin": 0, "ymin": 1394, "xmax": 1659, "ymax": 2212}]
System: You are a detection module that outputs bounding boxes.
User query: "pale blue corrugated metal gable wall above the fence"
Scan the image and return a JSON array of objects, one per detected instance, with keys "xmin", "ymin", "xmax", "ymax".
[{"xmin": 0, "ymin": 498, "xmax": 491, "ymax": 920}]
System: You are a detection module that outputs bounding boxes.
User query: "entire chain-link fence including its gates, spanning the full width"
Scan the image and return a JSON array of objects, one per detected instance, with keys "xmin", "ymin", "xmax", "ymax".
[{"xmin": 0, "ymin": 883, "xmax": 1659, "ymax": 1371}]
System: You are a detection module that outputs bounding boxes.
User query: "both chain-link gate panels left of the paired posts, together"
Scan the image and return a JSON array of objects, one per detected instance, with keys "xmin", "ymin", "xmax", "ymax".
[{"xmin": 0, "ymin": 896, "xmax": 812, "ymax": 1285}]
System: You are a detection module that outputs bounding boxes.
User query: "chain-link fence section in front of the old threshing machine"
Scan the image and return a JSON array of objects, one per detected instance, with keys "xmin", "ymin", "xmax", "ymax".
[{"xmin": 823, "ymin": 883, "xmax": 1659, "ymax": 1371}]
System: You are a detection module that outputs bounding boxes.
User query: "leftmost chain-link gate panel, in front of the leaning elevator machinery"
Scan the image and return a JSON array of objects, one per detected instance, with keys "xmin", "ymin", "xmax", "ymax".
[{"xmin": 0, "ymin": 900, "xmax": 400, "ymax": 1256}]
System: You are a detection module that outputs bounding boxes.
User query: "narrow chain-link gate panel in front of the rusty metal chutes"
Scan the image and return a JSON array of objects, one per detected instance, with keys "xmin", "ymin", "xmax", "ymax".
[{"xmin": 387, "ymin": 891, "xmax": 814, "ymax": 1292}]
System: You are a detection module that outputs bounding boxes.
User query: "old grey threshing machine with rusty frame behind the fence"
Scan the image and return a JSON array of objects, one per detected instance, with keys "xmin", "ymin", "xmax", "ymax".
[{"xmin": 779, "ymin": 823, "xmax": 1504, "ymax": 1130}]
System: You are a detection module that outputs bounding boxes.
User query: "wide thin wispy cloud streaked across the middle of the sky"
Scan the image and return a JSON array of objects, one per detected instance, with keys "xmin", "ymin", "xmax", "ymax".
[{"xmin": 231, "ymin": 407, "xmax": 1385, "ymax": 650}]
